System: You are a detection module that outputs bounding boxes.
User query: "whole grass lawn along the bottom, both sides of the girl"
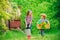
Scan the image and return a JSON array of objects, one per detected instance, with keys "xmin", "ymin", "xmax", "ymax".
[{"xmin": 0, "ymin": 30, "xmax": 60, "ymax": 40}]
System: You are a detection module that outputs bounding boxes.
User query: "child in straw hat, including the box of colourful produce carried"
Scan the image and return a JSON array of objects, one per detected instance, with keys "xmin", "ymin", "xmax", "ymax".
[{"xmin": 37, "ymin": 14, "xmax": 50, "ymax": 36}]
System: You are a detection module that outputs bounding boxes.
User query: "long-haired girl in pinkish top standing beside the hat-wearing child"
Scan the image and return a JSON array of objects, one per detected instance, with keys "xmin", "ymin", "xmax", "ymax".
[{"xmin": 25, "ymin": 10, "xmax": 32, "ymax": 40}]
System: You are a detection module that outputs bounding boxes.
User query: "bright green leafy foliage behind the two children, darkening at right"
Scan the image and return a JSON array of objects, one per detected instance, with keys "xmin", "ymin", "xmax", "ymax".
[{"xmin": 12, "ymin": 0, "xmax": 60, "ymax": 33}]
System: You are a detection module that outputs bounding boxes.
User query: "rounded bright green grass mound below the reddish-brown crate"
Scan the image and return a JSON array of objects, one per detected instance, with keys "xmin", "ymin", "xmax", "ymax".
[{"xmin": 0, "ymin": 30, "xmax": 26, "ymax": 40}]
